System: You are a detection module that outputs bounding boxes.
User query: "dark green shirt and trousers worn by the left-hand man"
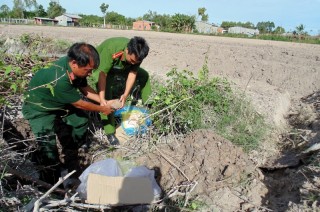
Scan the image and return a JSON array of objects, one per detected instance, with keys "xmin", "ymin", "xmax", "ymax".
[{"xmin": 22, "ymin": 57, "xmax": 88, "ymax": 169}]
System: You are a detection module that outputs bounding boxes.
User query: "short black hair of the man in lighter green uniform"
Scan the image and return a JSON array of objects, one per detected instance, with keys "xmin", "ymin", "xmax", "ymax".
[{"xmin": 127, "ymin": 36, "xmax": 149, "ymax": 61}]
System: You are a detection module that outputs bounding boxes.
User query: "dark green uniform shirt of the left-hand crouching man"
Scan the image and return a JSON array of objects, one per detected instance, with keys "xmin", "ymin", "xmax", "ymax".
[{"xmin": 24, "ymin": 57, "xmax": 87, "ymax": 115}]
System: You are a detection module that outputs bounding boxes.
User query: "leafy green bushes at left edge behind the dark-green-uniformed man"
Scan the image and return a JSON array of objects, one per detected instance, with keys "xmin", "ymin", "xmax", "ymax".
[{"xmin": 0, "ymin": 34, "xmax": 70, "ymax": 107}]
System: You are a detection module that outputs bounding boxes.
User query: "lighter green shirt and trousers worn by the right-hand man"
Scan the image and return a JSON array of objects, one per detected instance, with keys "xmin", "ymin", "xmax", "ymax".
[{"xmin": 93, "ymin": 37, "xmax": 151, "ymax": 134}]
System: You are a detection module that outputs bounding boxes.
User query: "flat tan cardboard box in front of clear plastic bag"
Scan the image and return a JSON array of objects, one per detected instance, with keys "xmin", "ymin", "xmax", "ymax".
[{"xmin": 87, "ymin": 173, "xmax": 154, "ymax": 205}]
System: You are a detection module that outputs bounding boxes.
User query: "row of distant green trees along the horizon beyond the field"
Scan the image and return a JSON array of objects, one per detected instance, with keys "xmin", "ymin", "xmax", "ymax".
[{"xmin": 0, "ymin": 0, "xmax": 306, "ymax": 34}]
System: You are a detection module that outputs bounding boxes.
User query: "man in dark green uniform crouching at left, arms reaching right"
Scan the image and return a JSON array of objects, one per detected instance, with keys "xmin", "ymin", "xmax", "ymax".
[{"xmin": 22, "ymin": 43, "xmax": 113, "ymax": 182}]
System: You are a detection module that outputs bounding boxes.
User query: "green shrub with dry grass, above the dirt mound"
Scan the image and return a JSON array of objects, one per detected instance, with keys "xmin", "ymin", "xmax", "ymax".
[{"xmin": 150, "ymin": 59, "xmax": 267, "ymax": 150}]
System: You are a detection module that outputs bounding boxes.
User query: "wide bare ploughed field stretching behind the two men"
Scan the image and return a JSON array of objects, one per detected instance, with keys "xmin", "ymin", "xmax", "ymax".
[{"xmin": 0, "ymin": 25, "xmax": 320, "ymax": 126}]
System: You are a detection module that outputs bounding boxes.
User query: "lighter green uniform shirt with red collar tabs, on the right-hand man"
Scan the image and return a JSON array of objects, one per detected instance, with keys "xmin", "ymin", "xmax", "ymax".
[{"xmin": 92, "ymin": 37, "xmax": 140, "ymax": 82}]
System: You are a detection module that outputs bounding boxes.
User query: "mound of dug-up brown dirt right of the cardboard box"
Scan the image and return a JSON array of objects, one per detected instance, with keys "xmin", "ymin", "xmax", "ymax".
[{"xmin": 131, "ymin": 130, "xmax": 254, "ymax": 210}]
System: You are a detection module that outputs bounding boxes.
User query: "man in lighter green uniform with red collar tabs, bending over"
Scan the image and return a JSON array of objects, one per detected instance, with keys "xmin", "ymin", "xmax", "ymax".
[{"xmin": 93, "ymin": 37, "xmax": 151, "ymax": 145}]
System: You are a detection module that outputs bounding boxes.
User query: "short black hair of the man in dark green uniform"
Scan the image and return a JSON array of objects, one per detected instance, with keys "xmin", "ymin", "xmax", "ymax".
[{"xmin": 68, "ymin": 42, "xmax": 100, "ymax": 69}]
